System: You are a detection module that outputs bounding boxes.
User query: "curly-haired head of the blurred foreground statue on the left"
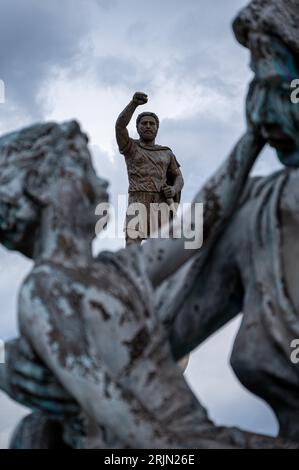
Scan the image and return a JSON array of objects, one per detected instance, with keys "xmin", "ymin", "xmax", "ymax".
[{"xmin": 0, "ymin": 121, "xmax": 108, "ymax": 257}]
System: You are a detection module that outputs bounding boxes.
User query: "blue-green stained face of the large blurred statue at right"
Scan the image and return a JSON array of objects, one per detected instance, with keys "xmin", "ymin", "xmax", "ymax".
[{"xmin": 247, "ymin": 37, "xmax": 299, "ymax": 167}]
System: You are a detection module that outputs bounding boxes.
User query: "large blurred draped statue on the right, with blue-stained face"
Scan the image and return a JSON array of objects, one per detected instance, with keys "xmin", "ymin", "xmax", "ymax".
[{"xmin": 160, "ymin": 0, "xmax": 299, "ymax": 442}]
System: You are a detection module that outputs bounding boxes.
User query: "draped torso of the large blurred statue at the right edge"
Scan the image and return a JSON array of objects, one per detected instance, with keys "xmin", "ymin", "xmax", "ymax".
[{"xmin": 227, "ymin": 173, "xmax": 299, "ymax": 439}]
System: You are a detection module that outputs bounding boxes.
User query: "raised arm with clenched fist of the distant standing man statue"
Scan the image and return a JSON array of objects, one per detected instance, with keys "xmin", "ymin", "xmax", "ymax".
[{"xmin": 115, "ymin": 92, "xmax": 147, "ymax": 151}]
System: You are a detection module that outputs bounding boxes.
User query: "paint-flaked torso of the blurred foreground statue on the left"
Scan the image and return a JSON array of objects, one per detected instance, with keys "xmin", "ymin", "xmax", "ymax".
[{"xmin": 20, "ymin": 247, "xmax": 209, "ymax": 448}]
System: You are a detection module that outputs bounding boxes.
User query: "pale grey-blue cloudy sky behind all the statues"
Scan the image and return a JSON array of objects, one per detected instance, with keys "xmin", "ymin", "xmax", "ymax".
[{"xmin": 0, "ymin": 0, "xmax": 286, "ymax": 447}]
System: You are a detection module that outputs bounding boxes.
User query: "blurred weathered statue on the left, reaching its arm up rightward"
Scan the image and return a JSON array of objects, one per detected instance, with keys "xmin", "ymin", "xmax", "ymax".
[{"xmin": 0, "ymin": 114, "xmax": 290, "ymax": 448}]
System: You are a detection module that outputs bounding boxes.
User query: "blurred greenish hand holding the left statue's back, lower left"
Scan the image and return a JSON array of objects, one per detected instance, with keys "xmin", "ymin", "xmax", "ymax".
[{"xmin": 1, "ymin": 338, "xmax": 80, "ymax": 419}]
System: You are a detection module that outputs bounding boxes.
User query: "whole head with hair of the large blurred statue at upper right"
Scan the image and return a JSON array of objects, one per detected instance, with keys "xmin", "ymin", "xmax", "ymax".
[{"xmin": 233, "ymin": 0, "xmax": 299, "ymax": 167}]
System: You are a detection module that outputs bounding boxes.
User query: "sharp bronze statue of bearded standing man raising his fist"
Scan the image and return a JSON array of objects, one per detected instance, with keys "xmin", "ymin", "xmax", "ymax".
[{"xmin": 115, "ymin": 92, "xmax": 184, "ymax": 245}]
